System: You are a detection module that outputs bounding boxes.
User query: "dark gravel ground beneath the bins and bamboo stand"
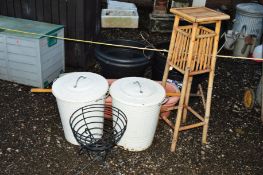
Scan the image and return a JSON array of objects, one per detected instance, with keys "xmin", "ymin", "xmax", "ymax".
[{"xmin": 0, "ymin": 6, "xmax": 263, "ymax": 175}]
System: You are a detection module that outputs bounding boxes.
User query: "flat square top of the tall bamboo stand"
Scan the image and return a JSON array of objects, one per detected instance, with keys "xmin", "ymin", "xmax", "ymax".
[{"xmin": 170, "ymin": 7, "xmax": 230, "ymax": 23}]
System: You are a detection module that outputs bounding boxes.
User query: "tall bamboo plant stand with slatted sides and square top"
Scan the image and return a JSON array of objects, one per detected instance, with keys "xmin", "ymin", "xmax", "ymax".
[{"xmin": 162, "ymin": 7, "xmax": 230, "ymax": 152}]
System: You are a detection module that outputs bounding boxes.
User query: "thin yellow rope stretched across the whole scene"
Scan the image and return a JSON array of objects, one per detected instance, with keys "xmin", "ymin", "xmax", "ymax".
[{"xmin": 0, "ymin": 27, "xmax": 263, "ymax": 61}]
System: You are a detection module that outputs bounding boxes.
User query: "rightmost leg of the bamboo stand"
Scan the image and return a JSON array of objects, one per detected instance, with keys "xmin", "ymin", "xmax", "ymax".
[{"xmin": 202, "ymin": 21, "xmax": 221, "ymax": 143}]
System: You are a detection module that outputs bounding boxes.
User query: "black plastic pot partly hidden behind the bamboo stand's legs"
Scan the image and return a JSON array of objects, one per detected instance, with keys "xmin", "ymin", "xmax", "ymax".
[{"xmin": 152, "ymin": 42, "xmax": 208, "ymax": 93}]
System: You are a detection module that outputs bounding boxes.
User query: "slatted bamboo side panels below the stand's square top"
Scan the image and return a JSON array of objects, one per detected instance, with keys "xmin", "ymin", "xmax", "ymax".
[{"xmin": 170, "ymin": 26, "xmax": 215, "ymax": 73}]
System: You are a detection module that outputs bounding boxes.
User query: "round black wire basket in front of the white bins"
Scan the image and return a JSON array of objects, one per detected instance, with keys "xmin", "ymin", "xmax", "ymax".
[{"xmin": 69, "ymin": 104, "xmax": 127, "ymax": 157}]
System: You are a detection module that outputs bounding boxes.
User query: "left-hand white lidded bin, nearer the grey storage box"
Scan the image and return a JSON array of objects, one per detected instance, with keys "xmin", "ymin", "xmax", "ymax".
[{"xmin": 52, "ymin": 72, "xmax": 109, "ymax": 145}]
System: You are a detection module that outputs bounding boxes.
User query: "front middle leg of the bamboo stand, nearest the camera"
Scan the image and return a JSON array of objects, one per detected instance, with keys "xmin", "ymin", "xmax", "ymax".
[{"xmin": 171, "ymin": 23, "xmax": 198, "ymax": 152}]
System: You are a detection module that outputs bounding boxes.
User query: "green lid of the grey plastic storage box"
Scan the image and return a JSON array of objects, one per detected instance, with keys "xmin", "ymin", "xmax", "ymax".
[{"xmin": 0, "ymin": 15, "xmax": 64, "ymax": 39}]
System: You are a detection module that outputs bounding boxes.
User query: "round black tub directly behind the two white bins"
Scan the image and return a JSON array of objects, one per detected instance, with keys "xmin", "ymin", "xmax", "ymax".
[{"xmin": 95, "ymin": 40, "xmax": 153, "ymax": 79}]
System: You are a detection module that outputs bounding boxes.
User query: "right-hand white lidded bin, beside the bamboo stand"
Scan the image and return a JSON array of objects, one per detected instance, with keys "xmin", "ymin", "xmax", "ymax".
[{"xmin": 110, "ymin": 77, "xmax": 165, "ymax": 151}]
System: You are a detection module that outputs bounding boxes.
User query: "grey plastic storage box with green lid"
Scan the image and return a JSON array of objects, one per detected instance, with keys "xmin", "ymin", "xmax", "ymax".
[{"xmin": 0, "ymin": 16, "xmax": 65, "ymax": 88}]
